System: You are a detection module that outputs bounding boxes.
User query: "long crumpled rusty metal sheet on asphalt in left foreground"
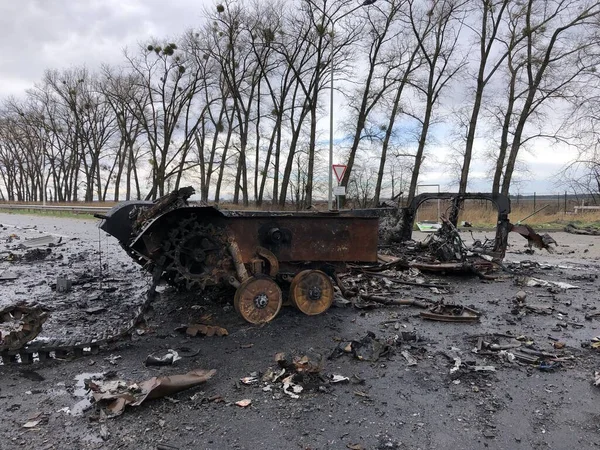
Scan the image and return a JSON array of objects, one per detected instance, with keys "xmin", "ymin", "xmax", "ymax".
[{"xmin": 88, "ymin": 369, "xmax": 216, "ymax": 418}]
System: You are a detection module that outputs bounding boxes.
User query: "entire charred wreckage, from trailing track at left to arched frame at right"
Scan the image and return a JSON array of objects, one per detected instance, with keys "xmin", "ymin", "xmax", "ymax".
[{"xmin": 0, "ymin": 187, "xmax": 555, "ymax": 362}]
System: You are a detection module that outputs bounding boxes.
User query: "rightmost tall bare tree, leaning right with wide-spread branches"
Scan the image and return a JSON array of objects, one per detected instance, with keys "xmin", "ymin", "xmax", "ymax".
[{"xmin": 497, "ymin": 0, "xmax": 600, "ymax": 195}]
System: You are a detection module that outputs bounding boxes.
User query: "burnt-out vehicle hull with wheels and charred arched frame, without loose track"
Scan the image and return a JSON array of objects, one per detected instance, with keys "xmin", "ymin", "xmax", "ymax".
[{"xmin": 98, "ymin": 187, "xmax": 547, "ymax": 324}]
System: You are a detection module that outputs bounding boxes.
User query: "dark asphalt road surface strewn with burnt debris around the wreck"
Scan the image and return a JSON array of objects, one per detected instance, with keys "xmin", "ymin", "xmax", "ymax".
[{"xmin": 0, "ymin": 214, "xmax": 600, "ymax": 449}]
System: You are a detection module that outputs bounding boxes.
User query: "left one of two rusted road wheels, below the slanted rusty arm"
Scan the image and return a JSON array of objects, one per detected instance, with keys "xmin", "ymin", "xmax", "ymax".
[{"xmin": 233, "ymin": 277, "xmax": 282, "ymax": 324}]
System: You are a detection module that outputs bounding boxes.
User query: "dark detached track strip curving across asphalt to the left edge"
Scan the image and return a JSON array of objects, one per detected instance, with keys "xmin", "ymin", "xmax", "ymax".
[{"xmin": 0, "ymin": 284, "xmax": 156, "ymax": 364}]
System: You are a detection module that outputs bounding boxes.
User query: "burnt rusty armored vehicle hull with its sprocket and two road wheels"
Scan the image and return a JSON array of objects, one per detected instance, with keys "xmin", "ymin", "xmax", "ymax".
[{"xmin": 100, "ymin": 188, "xmax": 379, "ymax": 323}]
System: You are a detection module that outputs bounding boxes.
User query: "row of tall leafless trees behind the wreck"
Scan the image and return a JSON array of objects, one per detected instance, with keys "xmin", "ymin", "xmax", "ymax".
[{"xmin": 0, "ymin": 0, "xmax": 600, "ymax": 207}]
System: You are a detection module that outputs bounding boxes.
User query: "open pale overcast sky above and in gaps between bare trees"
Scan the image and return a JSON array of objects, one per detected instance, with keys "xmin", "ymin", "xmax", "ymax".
[{"xmin": 0, "ymin": 0, "xmax": 569, "ymax": 193}]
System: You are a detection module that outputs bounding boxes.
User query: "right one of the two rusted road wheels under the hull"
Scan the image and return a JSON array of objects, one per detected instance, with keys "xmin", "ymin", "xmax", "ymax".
[{"xmin": 290, "ymin": 270, "xmax": 333, "ymax": 316}]
